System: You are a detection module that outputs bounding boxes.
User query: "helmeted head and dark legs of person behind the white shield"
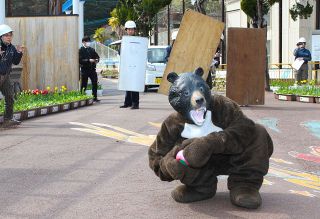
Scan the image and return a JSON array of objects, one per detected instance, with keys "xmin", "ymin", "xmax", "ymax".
[{"xmin": 120, "ymin": 21, "xmax": 139, "ymax": 109}]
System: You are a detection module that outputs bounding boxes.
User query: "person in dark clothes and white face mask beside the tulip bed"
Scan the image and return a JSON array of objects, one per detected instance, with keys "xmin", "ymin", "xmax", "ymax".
[{"xmin": 79, "ymin": 36, "xmax": 100, "ymax": 102}]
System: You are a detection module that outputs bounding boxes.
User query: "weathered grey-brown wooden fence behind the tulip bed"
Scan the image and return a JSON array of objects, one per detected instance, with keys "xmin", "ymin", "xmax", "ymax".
[{"xmin": 6, "ymin": 16, "xmax": 79, "ymax": 90}]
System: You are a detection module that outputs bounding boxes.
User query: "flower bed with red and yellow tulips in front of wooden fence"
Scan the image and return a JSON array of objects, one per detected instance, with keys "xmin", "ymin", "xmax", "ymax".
[{"xmin": 0, "ymin": 86, "xmax": 93, "ymax": 122}]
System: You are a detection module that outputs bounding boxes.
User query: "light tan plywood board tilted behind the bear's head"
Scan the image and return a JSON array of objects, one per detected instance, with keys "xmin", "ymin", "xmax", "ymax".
[{"xmin": 159, "ymin": 10, "xmax": 224, "ymax": 95}]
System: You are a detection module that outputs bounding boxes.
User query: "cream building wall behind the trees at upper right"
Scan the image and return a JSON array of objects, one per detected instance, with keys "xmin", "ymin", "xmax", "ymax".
[{"xmin": 226, "ymin": 0, "xmax": 316, "ymax": 63}]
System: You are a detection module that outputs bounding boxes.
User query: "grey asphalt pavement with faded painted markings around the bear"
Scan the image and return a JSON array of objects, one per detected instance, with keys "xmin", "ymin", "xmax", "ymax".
[{"xmin": 0, "ymin": 79, "xmax": 320, "ymax": 219}]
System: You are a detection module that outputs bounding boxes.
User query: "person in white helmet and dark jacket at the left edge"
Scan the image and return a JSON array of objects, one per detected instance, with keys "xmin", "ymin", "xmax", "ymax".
[{"xmin": 0, "ymin": 24, "xmax": 24, "ymax": 127}]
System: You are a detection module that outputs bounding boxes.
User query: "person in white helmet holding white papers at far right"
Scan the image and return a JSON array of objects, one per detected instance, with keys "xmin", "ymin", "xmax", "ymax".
[{"xmin": 293, "ymin": 37, "xmax": 311, "ymax": 83}]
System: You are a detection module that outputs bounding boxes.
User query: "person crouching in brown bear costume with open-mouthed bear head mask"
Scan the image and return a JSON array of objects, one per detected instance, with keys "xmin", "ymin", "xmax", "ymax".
[{"xmin": 148, "ymin": 68, "xmax": 273, "ymax": 209}]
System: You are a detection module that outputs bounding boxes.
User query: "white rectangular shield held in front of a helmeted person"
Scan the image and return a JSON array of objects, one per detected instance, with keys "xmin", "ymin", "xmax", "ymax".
[{"xmin": 118, "ymin": 36, "xmax": 148, "ymax": 92}]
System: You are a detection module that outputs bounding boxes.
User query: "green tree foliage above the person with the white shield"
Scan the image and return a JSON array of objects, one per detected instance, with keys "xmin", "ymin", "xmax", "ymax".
[{"xmin": 109, "ymin": 0, "xmax": 172, "ymax": 37}]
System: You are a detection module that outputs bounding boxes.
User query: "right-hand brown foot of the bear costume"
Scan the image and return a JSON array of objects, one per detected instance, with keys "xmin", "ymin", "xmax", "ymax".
[{"xmin": 230, "ymin": 187, "xmax": 262, "ymax": 209}]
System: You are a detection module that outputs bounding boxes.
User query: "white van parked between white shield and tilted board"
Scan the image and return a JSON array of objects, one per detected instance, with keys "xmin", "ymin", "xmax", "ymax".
[{"xmin": 145, "ymin": 46, "xmax": 168, "ymax": 91}]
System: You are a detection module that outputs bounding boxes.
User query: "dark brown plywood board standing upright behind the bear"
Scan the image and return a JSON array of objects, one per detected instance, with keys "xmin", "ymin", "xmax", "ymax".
[{"xmin": 226, "ymin": 28, "xmax": 266, "ymax": 105}]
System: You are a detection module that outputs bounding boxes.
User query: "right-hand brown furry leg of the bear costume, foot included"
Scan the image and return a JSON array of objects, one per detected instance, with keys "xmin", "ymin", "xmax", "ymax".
[{"xmin": 228, "ymin": 124, "xmax": 273, "ymax": 209}]
